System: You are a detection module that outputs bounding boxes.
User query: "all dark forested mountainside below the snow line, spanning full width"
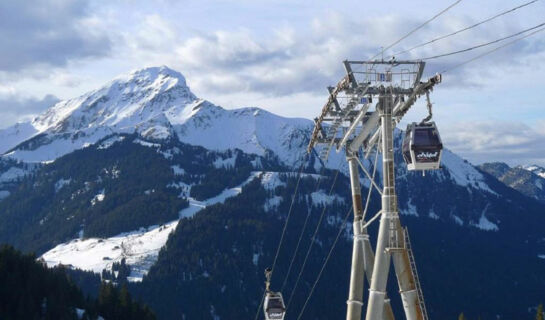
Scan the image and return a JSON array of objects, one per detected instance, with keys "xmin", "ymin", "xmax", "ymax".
[{"xmin": 0, "ymin": 135, "xmax": 545, "ymax": 319}]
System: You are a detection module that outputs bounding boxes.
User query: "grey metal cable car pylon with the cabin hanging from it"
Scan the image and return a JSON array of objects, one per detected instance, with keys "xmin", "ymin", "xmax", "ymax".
[{"xmin": 307, "ymin": 59, "xmax": 442, "ymax": 320}]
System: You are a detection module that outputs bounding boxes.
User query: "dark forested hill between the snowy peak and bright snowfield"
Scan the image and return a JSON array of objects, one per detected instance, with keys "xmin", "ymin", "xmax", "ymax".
[{"xmin": 0, "ymin": 135, "xmax": 278, "ymax": 253}]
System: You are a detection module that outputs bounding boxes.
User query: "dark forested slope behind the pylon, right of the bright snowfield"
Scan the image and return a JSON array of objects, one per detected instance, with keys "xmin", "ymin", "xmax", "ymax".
[{"xmin": 131, "ymin": 168, "xmax": 545, "ymax": 319}]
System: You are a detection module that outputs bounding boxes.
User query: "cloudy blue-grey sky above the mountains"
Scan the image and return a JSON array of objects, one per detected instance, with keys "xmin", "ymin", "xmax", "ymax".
[{"xmin": 0, "ymin": 0, "xmax": 545, "ymax": 165}]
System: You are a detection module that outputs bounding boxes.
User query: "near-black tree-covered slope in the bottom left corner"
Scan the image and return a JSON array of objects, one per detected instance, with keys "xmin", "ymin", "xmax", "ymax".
[{"xmin": 0, "ymin": 246, "xmax": 155, "ymax": 320}]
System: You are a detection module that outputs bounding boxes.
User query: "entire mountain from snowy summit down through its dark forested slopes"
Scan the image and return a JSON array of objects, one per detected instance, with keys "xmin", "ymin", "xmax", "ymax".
[{"xmin": 0, "ymin": 67, "xmax": 545, "ymax": 319}]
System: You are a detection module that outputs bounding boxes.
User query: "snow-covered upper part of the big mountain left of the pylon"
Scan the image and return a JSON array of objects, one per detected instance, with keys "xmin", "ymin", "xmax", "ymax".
[{"xmin": 0, "ymin": 67, "xmax": 312, "ymax": 164}]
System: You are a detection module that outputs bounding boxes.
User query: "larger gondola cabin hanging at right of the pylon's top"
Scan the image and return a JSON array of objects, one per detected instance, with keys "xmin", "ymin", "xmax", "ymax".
[{"xmin": 402, "ymin": 122, "xmax": 443, "ymax": 170}]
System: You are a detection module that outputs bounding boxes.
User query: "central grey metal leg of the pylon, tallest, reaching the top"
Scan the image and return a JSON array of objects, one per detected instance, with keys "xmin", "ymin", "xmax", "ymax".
[{"xmin": 365, "ymin": 90, "xmax": 397, "ymax": 320}]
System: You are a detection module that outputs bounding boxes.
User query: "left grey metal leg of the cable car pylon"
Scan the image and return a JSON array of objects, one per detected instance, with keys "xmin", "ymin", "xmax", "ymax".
[{"xmin": 346, "ymin": 153, "xmax": 369, "ymax": 320}]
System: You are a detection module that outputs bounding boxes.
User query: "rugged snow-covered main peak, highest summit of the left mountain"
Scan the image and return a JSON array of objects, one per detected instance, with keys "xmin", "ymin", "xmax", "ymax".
[{"xmin": 32, "ymin": 66, "xmax": 197, "ymax": 133}]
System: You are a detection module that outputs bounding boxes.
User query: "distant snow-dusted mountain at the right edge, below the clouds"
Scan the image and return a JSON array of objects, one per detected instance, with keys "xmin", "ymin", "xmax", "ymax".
[{"xmin": 479, "ymin": 162, "xmax": 545, "ymax": 202}]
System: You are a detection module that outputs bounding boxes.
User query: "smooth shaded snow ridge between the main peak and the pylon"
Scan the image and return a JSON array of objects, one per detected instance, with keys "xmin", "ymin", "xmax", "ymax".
[{"xmin": 171, "ymin": 101, "xmax": 312, "ymax": 168}]
